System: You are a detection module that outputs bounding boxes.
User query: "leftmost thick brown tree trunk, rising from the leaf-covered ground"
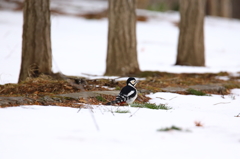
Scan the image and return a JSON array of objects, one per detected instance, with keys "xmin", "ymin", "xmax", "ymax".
[{"xmin": 18, "ymin": 0, "xmax": 52, "ymax": 82}]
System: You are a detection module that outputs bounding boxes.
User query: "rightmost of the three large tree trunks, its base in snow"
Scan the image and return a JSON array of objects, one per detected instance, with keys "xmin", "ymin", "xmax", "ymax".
[{"xmin": 176, "ymin": 0, "xmax": 205, "ymax": 66}]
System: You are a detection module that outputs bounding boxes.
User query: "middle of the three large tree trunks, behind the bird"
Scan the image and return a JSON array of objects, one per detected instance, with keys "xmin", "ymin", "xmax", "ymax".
[{"xmin": 105, "ymin": 0, "xmax": 140, "ymax": 76}]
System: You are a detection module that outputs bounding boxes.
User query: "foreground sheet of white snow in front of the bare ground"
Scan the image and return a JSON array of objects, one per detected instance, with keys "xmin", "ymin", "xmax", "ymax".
[{"xmin": 0, "ymin": 89, "xmax": 240, "ymax": 159}]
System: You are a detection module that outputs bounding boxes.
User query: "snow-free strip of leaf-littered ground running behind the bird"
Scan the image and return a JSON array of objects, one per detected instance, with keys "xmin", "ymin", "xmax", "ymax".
[{"xmin": 0, "ymin": 71, "xmax": 240, "ymax": 107}]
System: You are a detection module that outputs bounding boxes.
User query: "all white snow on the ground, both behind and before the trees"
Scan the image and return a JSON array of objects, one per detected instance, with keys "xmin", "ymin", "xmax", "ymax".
[{"xmin": 0, "ymin": 2, "xmax": 240, "ymax": 159}]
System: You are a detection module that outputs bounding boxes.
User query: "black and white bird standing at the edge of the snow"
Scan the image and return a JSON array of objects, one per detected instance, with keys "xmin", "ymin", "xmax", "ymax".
[{"xmin": 106, "ymin": 77, "xmax": 138, "ymax": 106}]
